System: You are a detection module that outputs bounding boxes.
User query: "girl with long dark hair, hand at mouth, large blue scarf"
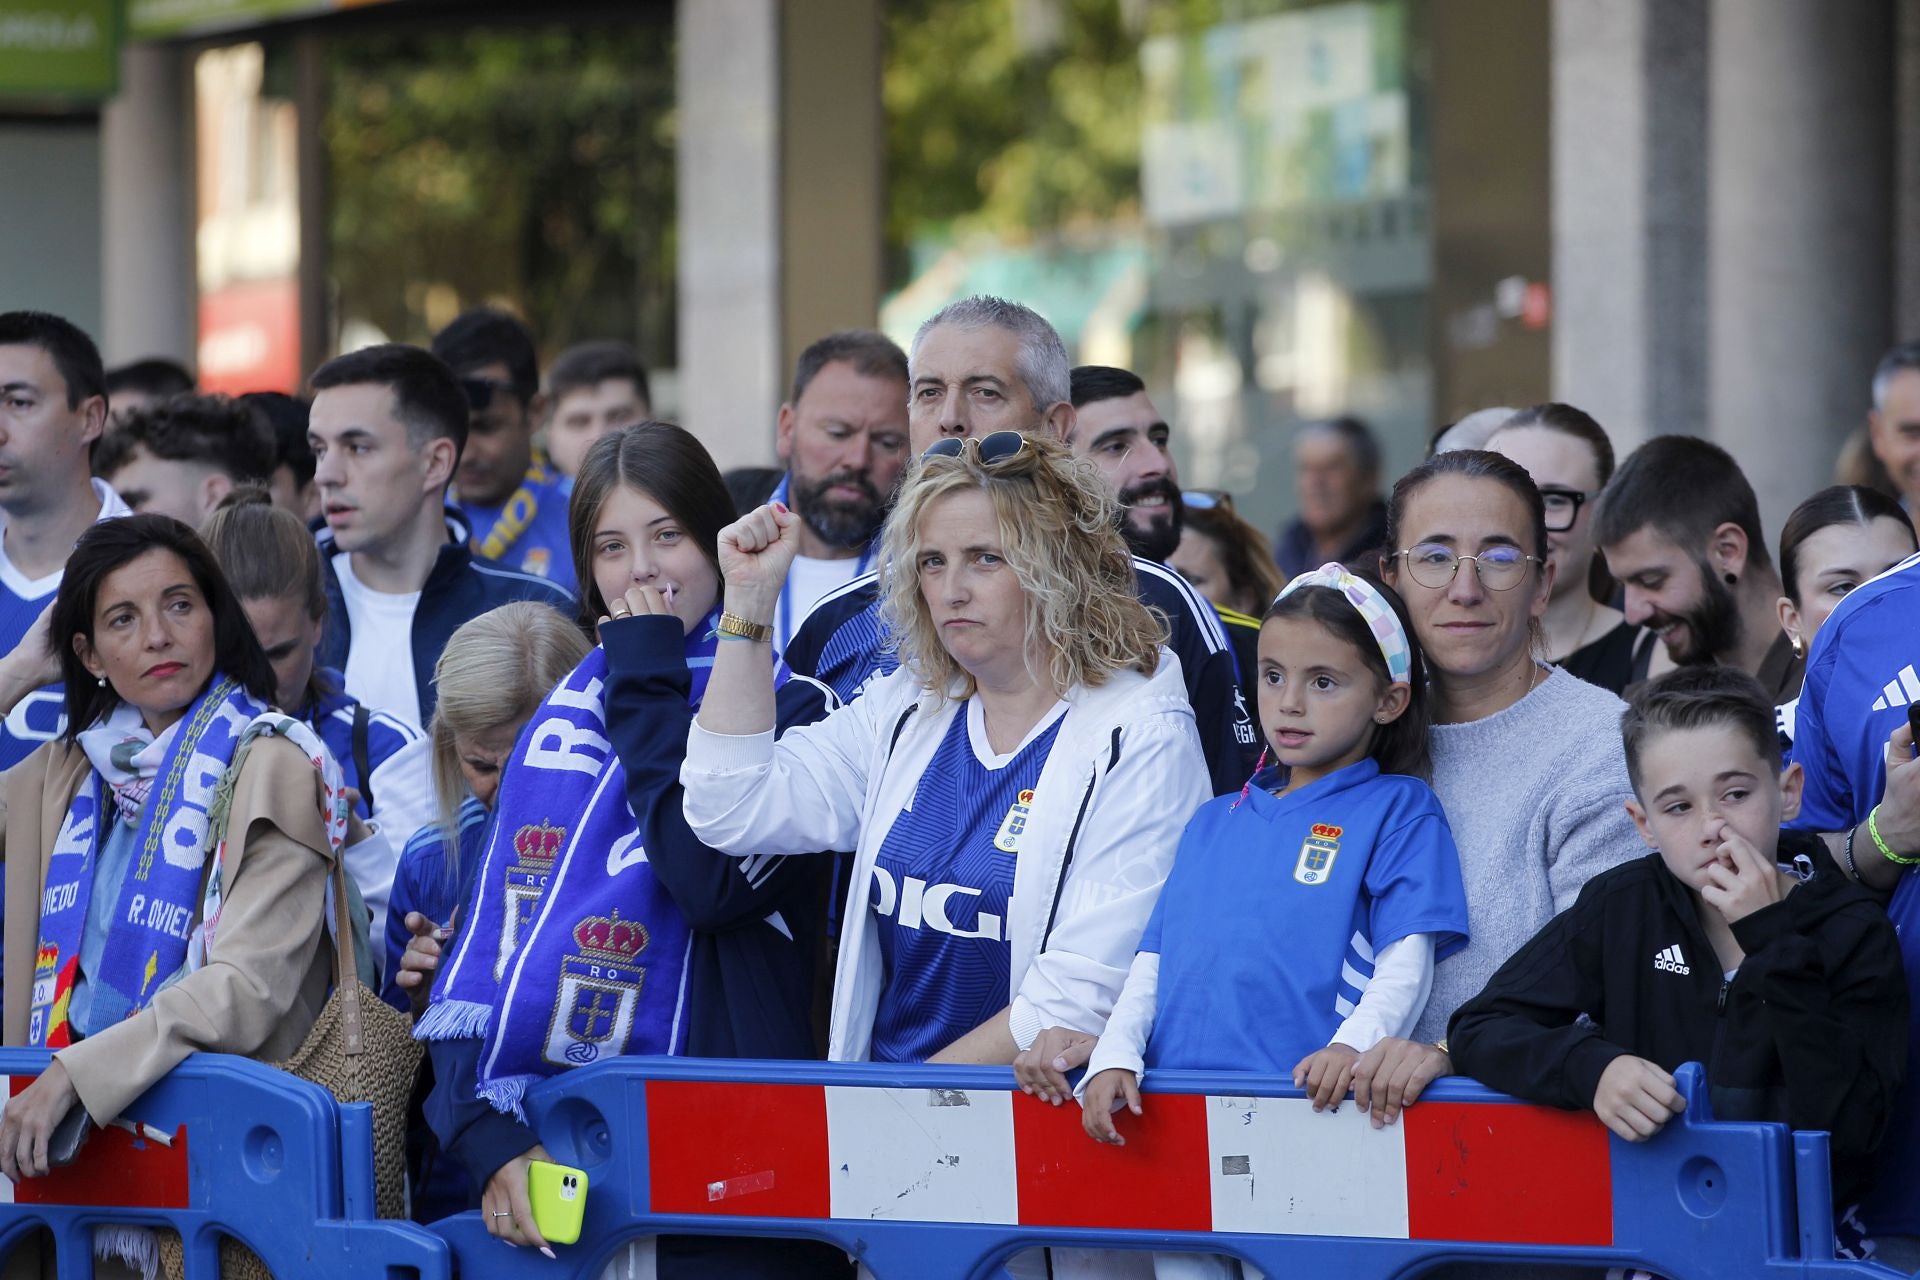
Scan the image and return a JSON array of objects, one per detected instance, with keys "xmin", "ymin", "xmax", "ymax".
[{"xmin": 419, "ymin": 422, "xmax": 847, "ymax": 1276}]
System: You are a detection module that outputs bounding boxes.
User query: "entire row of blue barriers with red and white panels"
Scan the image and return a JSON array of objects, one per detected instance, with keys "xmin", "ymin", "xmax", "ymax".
[{"xmin": 0, "ymin": 1050, "xmax": 1895, "ymax": 1280}]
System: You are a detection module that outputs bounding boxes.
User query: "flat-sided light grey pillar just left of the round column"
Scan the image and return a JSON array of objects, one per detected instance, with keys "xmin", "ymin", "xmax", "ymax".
[{"xmin": 1551, "ymin": 0, "xmax": 1707, "ymax": 455}]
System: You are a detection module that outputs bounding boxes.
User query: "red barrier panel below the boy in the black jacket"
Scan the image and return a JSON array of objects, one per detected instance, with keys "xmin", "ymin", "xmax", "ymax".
[{"xmin": 1400, "ymin": 1102, "xmax": 1613, "ymax": 1245}]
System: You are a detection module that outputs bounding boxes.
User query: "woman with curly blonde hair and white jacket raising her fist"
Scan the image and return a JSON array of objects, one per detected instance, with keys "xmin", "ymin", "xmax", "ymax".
[{"xmin": 682, "ymin": 432, "xmax": 1212, "ymax": 1103}]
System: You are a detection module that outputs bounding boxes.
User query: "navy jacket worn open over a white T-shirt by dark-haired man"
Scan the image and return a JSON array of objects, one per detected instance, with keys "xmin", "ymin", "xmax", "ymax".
[{"xmin": 313, "ymin": 507, "xmax": 574, "ymax": 725}]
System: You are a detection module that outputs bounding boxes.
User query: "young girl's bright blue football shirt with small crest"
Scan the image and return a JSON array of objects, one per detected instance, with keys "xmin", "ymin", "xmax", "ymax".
[{"xmin": 1140, "ymin": 760, "xmax": 1467, "ymax": 1073}]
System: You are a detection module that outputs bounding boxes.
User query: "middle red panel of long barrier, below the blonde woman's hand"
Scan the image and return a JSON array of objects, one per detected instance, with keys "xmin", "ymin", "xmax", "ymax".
[{"xmin": 1014, "ymin": 1094, "xmax": 1213, "ymax": 1232}]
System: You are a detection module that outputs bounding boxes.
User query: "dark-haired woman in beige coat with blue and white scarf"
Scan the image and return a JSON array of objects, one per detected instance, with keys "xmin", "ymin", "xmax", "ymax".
[{"xmin": 0, "ymin": 516, "xmax": 346, "ymax": 1261}]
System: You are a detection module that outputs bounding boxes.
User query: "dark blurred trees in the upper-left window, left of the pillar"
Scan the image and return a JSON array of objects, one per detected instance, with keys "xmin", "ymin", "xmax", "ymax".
[{"xmin": 324, "ymin": 22, "xmax": 674, "ymax": 365}]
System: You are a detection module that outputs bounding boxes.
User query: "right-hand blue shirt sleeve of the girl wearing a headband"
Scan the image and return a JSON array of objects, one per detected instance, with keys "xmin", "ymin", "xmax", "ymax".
[{"xmin": 1365, "ymin": 783, "xmax": 1467, "ymax": 960}]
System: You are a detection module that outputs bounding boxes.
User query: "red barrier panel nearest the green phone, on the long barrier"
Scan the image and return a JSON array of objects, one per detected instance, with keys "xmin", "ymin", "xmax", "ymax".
[{"xmin": 647, "ymin": 1080, "xmax": 829, "ymax": 1219}]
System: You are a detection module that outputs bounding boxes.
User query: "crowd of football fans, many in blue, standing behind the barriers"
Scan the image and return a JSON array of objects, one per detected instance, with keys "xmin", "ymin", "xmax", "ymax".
[{"xmin": 0, "ymin": 297, "xmax": 1920, "ymax": 1276}]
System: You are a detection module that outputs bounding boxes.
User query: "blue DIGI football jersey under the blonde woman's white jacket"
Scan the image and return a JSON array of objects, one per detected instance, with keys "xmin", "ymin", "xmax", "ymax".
[{"xmin": 870, "ymin": 699, "xmax": 1066, "ymax": 1063}]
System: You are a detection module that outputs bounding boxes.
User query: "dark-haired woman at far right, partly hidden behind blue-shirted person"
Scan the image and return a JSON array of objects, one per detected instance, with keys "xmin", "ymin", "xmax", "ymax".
[{"xmin": 1763, "ymin": 484, "xmax": 1914, "ymax": 748}]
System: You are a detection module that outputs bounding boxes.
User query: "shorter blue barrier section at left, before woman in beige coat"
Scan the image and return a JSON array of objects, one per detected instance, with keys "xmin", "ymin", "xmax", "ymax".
[{"xmin": 0, "ymin": 1050, "xmax": 445, "ymax": 1280}]
